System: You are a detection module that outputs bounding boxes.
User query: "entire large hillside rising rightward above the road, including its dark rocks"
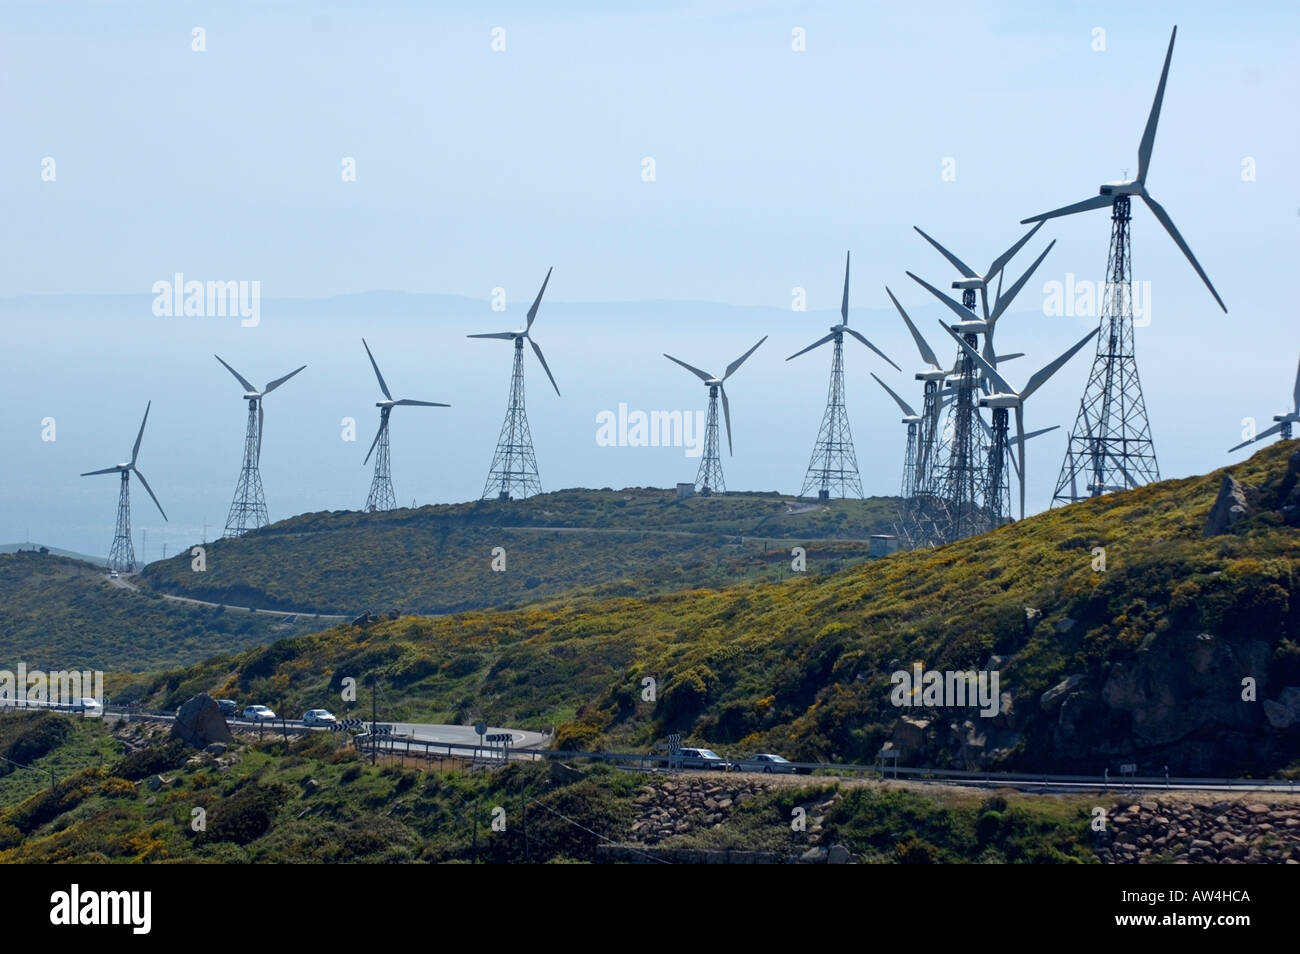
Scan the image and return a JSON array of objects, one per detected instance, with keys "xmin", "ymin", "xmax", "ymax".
[{"xmin": 129, "ymin": 442, "xmax": 1300, "ymax": 775}]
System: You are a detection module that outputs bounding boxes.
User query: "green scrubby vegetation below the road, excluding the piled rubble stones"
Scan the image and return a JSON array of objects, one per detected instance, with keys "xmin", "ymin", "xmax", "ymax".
[{"xmin": 0, "ymin": 714, "xmax": 1096, "ymax": 863}]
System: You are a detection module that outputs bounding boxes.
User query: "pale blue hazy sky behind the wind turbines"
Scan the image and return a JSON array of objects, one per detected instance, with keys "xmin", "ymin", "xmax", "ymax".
[{"xmin": 0, "ymin": 0, "xmax": 1300, "ymax": 556}]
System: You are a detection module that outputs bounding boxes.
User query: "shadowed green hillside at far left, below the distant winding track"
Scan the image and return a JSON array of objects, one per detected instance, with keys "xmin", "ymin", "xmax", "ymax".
[{"xmin": 0, "ymin": 551, "xmax": 330, "ymax": 670}]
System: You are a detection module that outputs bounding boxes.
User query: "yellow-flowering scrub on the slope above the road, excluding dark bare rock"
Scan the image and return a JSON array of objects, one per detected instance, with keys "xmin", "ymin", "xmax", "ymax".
[{"xmin": 131, "ymin": 445, "xmax": 1300, "ymax": 768}]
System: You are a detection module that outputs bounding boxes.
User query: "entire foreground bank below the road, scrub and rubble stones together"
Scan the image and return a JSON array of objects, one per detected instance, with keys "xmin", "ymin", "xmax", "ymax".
[{"xmin": 0, "ymin": 712, "xmax": 1300, "ymax": 864}]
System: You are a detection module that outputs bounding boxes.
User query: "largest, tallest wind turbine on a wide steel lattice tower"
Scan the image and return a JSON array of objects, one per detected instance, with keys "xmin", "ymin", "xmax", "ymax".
[{"xmin": 1022, "ymin": 26, "xmax": 1227, "ymax": 507}]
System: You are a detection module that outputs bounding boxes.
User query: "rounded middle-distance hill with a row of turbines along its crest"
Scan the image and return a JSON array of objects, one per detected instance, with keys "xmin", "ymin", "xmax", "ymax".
[{"xmin": 137, "ymin": 489, "xmax": 896, "ymax": 615}]
